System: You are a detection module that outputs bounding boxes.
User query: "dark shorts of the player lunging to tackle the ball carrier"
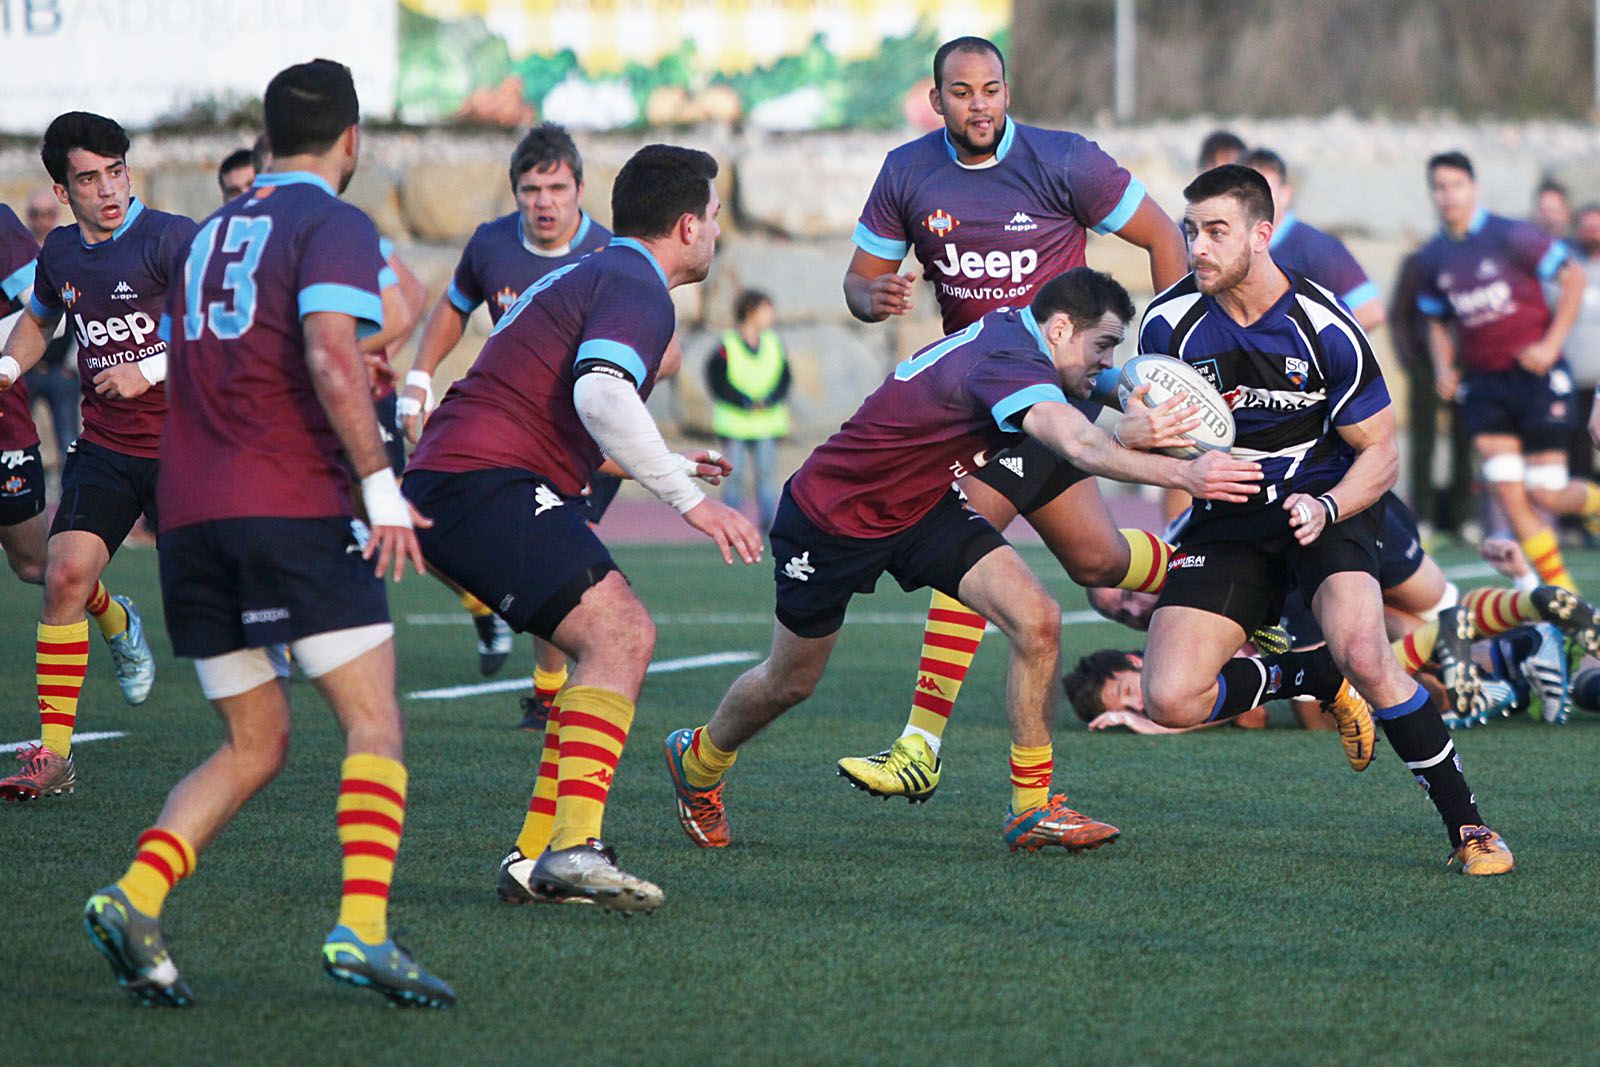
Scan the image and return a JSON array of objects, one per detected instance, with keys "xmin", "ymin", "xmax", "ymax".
[{"xmin": 768, "ymin": 485, "xmax": 1006, "ymax": 637}]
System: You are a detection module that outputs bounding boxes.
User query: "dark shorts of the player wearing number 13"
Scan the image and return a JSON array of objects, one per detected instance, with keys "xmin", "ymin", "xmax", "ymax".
[{"xmin": 160, "ymin": 517, "xmax": 389, "ymax": 659}]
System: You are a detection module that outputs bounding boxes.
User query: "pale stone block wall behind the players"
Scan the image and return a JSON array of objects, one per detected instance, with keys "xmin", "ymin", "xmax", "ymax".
[{"xmin": 12, "ymin": 115, "xmax": 1600, "ymax": 467}]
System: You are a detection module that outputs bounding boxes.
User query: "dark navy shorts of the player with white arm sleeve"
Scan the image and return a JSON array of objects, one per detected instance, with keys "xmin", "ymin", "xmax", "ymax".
[{"xmin": 402, "ymin": 470, "xmax": 618, "ymax": 640}]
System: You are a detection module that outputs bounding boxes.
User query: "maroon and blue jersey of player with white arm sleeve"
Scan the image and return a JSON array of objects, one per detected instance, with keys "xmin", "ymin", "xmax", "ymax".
[{"xmin": 410, "ymin": 238, "xmax": 677, "ymax": 496}]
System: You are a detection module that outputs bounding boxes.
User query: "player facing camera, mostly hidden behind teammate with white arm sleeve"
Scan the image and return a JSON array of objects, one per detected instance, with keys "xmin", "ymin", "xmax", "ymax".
[{"xmin": 398, "ymin": 123, "xmax": 621, "ymax": 716}]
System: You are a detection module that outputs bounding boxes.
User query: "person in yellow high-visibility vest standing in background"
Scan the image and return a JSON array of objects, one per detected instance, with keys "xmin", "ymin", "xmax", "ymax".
[{"xmin": 706, "ymin": 290, "xmax": 789, "ymax": 530}]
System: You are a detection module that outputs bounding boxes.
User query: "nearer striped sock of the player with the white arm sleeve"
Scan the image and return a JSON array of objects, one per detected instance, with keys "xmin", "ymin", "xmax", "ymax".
[{"xmin": 550, "ymin": 685, "xmax": 634, "ymax": 851}]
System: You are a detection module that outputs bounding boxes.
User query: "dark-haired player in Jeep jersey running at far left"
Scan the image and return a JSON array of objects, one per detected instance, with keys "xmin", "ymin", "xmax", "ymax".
[{"xmin": 0, "ymin": 112, "xmax": 195, "ymax": 800}]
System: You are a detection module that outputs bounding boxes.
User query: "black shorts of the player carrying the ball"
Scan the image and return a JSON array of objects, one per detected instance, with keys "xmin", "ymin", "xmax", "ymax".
[{"xmin": 1155, "ymin": 507, "xmax": 1384, "ymax": 633}]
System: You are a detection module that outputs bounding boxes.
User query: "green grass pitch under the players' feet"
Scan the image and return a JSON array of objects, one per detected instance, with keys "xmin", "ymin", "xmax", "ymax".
[{"xmin": 0, "ymin": 547, "xmax": 1600, "ymax": 1064}]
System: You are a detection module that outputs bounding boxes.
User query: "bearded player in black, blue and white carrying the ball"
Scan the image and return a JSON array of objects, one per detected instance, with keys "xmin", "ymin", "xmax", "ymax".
[{"xmin": 1139, "ymin": 165, "xmax": 1514, "ymax": 875}]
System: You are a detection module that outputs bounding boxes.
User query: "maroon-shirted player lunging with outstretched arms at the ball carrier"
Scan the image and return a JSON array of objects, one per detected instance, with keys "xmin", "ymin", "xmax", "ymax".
[{"xmin": 666, "ymin": 267, "xmax": 1261, "ymax": 851}]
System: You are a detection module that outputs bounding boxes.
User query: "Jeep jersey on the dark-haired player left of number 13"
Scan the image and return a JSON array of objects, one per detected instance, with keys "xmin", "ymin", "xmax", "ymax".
[{"xmin": 30, "ymin": 197, "xmax": 195, "ymax": 459}]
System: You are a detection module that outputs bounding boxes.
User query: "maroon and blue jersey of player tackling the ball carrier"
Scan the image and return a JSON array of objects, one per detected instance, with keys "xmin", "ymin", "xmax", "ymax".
[{"xmin": 789, "ymin": 307, "xmax": 1067, "ymax": 537}]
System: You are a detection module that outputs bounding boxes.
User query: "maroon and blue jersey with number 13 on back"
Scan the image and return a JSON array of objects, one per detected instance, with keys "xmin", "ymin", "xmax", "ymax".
[{"xmin": 158, "ymin": 171, "xmax": 384, "ymax": 531}]
